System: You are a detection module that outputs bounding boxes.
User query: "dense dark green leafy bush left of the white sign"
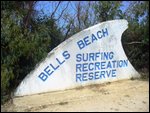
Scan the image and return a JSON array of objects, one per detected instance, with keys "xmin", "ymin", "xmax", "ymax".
[{"xmin": 1, "ymin": 2, "xmax": 62, "ymax": 103}]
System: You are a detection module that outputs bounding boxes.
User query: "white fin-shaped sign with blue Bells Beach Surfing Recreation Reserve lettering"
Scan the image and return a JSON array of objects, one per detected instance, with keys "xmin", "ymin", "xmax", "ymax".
[{"xmin": 14, "ymin": 20, "xmax": 140, "ymax": 96}]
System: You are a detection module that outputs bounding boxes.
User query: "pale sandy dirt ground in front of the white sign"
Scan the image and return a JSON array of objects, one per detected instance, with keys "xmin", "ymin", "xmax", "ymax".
[{"xmin": 1, "ymin": 79, "xmax": 149, "ymax": 112}]
